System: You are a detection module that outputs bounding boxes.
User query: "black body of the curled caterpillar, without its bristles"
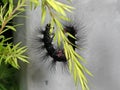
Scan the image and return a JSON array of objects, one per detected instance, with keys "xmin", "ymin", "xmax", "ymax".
[{"xmin": 41, "ymin": 24, "xmax": 76, "ymax": 63}]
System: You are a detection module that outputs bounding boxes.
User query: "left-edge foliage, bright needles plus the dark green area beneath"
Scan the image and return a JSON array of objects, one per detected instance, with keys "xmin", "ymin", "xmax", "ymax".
[{"xmin": 0, "ymin": 0, "xmax": 28, "ymax": 90}]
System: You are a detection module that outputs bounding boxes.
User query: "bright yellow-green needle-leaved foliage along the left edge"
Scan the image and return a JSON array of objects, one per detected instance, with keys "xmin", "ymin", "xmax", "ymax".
[{"xmin": 0, "ymin": 0, "xmax": 28, "ymax": 69}]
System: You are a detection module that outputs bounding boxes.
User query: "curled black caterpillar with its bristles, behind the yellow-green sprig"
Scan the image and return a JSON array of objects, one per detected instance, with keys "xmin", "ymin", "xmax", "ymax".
[{"xmin": 30, "ymin": 24, "xmax": 83, "ymax": 67}]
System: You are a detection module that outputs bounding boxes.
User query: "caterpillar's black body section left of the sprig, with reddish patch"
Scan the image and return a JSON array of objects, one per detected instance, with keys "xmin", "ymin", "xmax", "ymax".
[{"xmin": 42, "ymin": 24, "xmax": 67, "ymax": 62}]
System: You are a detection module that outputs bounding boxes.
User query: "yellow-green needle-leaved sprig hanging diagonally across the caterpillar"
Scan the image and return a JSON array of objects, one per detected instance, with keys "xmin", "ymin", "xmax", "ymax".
[{"xmin": 41, "ymin": 0, "xmax": 93, "ymax": 90}]
